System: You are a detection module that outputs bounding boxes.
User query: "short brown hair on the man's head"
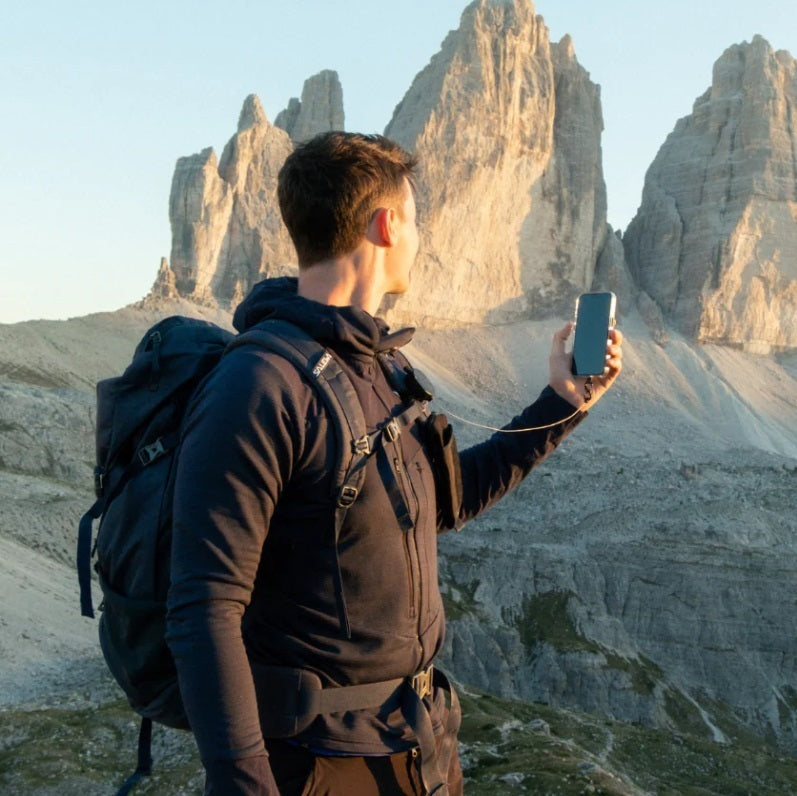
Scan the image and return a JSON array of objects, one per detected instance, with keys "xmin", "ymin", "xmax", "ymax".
[{"xmin": 277, "ymin": 132, "xmax": 417, "ymax": 267}]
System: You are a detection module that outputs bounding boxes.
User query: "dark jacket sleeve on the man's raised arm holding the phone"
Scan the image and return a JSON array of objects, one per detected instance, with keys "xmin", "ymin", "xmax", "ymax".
[{"xmin": 448, "ymin": 386, "xmax": 587, "ymax": 530}]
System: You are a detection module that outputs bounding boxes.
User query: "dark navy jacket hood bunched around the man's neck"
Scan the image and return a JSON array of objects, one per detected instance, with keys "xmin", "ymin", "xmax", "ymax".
[{"xmin": 232, "ymin": 276, "xmax": 415, "ymax": 357}]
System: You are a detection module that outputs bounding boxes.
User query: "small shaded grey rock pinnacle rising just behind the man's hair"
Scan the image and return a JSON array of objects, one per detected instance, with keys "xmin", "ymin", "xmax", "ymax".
[{"xmin": 274, "ymin": 69, "xmax": 343, "ymax": 141}]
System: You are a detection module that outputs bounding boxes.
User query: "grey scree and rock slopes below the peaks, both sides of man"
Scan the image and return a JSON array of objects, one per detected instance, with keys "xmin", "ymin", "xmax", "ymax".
[{"xmin": 0, "ymin": 303, "xmax": 797, "ymax": 760}]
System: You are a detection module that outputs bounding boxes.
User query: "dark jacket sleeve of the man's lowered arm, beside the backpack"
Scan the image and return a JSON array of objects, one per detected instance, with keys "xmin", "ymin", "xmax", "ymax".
[{"xmin": 167, "ymin": 349, "xmax": 304, "ymax": 796}]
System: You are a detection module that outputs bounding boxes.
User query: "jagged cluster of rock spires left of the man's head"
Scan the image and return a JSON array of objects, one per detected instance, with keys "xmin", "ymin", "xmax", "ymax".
[{"xmin": 151, "ymin": 71, "xmax": 343, "ymax": 307}]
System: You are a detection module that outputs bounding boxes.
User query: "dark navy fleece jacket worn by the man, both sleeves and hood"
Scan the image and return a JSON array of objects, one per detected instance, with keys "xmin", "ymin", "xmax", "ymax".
[{"xmin": 168, "ymin": 278, "xmax": 584, "ymax": 794}]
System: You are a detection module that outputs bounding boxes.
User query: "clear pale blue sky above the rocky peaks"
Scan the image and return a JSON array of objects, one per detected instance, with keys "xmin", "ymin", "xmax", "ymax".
[{"xmin": 0, "ymin": 0, "xmax": 797, "ymax": 323}]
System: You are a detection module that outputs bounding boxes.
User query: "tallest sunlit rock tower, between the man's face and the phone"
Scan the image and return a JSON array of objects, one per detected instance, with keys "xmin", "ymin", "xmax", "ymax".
[{"xmin": 385, "ymin": 0, "xmax": 606, "ymax": 327}]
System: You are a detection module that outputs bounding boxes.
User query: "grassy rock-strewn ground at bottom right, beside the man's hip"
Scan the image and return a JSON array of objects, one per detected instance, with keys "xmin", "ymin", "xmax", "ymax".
[{"xmin": 460, "ymin": 690, "xmax": 797, "ymax": 796}]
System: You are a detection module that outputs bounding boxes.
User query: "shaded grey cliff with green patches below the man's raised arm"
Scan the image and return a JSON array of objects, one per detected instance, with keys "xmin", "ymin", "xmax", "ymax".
[{"xmin": 441, "ymin": 439, "xmax": 797, "ymax": 750}]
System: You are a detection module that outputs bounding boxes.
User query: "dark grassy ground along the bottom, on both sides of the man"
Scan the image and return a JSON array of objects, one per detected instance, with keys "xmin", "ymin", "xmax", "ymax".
[{"xmin": 0, "ymin": 688, "xmax": 797, "ymax": 796}]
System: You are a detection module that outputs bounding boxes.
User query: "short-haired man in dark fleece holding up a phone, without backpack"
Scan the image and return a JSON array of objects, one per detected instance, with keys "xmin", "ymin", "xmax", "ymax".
[{"xmin": 163, "ymin": 133, "xmax": 621, "ymax": 796}]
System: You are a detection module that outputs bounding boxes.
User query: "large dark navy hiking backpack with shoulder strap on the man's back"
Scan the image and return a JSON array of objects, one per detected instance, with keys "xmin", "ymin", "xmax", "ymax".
[{"xmin": 77, "ymin": 316, "xmax": 422, "ymax": 795}]
